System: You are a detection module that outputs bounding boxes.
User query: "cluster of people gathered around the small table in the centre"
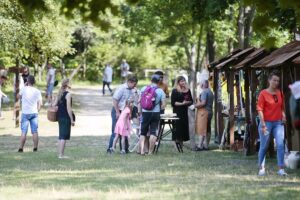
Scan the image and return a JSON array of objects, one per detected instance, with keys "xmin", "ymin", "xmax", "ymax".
[{"xmin": 107, "ymin": 71, "xmax": 214, "ymax": 155}]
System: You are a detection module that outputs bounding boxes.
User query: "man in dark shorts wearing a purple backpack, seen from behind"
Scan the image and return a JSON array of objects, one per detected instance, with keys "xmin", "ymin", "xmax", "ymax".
[{"xmin": 140, "ymin": 74, "xmax": 166, "ymax": 155}]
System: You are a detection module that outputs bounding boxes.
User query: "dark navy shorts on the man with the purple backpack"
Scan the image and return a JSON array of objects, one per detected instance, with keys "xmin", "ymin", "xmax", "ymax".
[{"xmin": 141, "ymin": 112, "xmax": 160, "ymax": 136}]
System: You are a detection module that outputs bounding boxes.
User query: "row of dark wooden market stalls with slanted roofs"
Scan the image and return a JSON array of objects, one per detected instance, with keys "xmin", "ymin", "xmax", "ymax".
[{"xmin": 209, "ymin": 41, "xmax": 300, "ymax": 155}]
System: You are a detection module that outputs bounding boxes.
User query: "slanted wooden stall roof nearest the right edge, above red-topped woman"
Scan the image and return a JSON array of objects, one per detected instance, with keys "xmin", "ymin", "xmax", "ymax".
[{"xmin": 252, "ymin": 41, "xmax": 300, "ymax": 68}]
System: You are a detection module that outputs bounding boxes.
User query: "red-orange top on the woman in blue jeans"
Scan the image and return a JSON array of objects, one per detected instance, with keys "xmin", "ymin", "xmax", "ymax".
[{"xmin": 256, "ymin": 89, "xmax": 283, "ymax": 121}]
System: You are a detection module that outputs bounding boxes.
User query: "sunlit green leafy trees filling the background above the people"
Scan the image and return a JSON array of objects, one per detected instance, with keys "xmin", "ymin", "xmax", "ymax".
[{"xmin": 0, "ymin": 0, "xmax": 300, "ymax": 83}]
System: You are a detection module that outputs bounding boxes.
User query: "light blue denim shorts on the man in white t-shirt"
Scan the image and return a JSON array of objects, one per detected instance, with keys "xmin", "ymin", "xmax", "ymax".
[{"xmin": 21, "ymin": 113, "xmax": 38, "ymax": 135}]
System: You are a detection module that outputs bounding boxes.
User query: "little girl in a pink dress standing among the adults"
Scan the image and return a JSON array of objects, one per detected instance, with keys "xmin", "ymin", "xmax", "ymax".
[{"xmin": 111, "ymin": 100, "xmax": 132, "ymax": 154}]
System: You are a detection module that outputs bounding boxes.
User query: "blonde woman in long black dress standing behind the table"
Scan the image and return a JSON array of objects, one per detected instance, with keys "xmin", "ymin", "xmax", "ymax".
[{"xmin": 171, "ymin": 76, "xmax": 193, "ymax": 146}]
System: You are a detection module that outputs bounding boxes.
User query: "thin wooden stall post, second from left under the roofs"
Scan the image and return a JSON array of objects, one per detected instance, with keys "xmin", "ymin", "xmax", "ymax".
[{"xmin": 228, "ymin": 70, "xmax": 234, "ymax": 149}]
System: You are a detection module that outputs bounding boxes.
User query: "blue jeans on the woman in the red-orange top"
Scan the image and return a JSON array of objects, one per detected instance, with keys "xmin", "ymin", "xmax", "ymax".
[{"xmin": 258, "ymin": 121, "xmax": 284, "ymax": 168}]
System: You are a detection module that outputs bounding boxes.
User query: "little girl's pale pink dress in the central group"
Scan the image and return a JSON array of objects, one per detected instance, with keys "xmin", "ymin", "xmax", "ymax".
[{"xmin": 115, "ymin": 107, "xmax": 131, "ymax": 136}]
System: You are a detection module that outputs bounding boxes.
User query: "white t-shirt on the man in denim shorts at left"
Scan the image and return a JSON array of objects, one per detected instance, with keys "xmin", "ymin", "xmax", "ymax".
[{"xmin": 20, "ymin": 86, "xmax": 42, "ymax": 114}]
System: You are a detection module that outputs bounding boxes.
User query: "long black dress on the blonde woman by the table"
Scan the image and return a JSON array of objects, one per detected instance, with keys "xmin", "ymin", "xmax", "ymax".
[{"xmin": 171, "ymin": 89, "xmax": 193, "ymax": 141}]
